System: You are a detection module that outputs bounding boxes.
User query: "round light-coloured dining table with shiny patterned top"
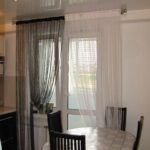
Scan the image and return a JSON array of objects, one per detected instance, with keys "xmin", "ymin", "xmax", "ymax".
[{"xmin": 43, "ymin": 127, "xmax": 135, "ymax": 150}]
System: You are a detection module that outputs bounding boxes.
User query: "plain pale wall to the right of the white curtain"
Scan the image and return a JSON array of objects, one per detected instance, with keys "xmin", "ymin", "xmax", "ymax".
[{"xmin": 122, "ymin": 21, "xmax": 150, "ymax": 150}]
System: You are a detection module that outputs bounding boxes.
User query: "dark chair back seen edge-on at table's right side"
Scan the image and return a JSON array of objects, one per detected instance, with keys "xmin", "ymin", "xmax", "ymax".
[{"xmin": 133, "ymin": 116, "xmax": 144, "ymax": 150}]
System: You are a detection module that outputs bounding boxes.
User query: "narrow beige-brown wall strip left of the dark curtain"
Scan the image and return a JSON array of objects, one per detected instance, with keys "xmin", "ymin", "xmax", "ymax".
[{"xmin": 4, "ymin": 32, "xmax": 16, "ymax": 107}]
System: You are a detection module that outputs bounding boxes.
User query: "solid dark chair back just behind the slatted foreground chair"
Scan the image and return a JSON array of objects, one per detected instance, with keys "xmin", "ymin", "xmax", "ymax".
[{"xmin": 47, "ymin": 111, "xmax": 62, "ymax": 132}]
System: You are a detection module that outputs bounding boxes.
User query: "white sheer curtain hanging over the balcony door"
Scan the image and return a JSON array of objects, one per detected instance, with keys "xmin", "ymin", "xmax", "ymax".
[{"xmin": 64, "ymin": 12, "xmax": 122, "ymax": 127}]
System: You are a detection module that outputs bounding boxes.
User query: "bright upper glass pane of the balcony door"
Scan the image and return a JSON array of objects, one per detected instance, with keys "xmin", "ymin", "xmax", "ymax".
[{"xmin": 68, "ymin": 38, "xmax": 97, "ymax": 109}]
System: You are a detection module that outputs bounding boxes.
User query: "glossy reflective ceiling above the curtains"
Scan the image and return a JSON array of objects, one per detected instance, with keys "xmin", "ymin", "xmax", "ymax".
[{"xmin": 0, "ymin": 0, "xmax": 150, "ymax": 24}]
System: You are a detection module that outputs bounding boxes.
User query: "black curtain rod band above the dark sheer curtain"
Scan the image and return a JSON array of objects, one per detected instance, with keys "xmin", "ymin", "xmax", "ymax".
[{"xmin": 16, "ymin": 16, "xmax": 65, "ymax": 25}]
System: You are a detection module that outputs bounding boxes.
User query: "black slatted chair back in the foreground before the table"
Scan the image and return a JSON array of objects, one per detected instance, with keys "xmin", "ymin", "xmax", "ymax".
[{"xmin": 50, "ymin": 131, "xmax": 86, "ymax": 150}]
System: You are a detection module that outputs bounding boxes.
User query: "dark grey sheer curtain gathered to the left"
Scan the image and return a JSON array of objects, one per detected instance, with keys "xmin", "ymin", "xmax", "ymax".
[{"xmin": 17, "ymin": 19, "xmax": 64, "ymax": 150}]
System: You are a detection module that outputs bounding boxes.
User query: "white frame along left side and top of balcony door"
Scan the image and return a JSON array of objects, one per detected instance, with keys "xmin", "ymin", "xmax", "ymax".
[{"xmin": 60, "ymin": 33, "xmax": 99, "ymax": 130}]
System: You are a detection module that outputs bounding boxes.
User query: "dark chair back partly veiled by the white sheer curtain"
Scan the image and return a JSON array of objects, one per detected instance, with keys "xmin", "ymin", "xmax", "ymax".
[{"xmin": 105, "ymin": 107, "xmax": 127, "ymax": 131}]
